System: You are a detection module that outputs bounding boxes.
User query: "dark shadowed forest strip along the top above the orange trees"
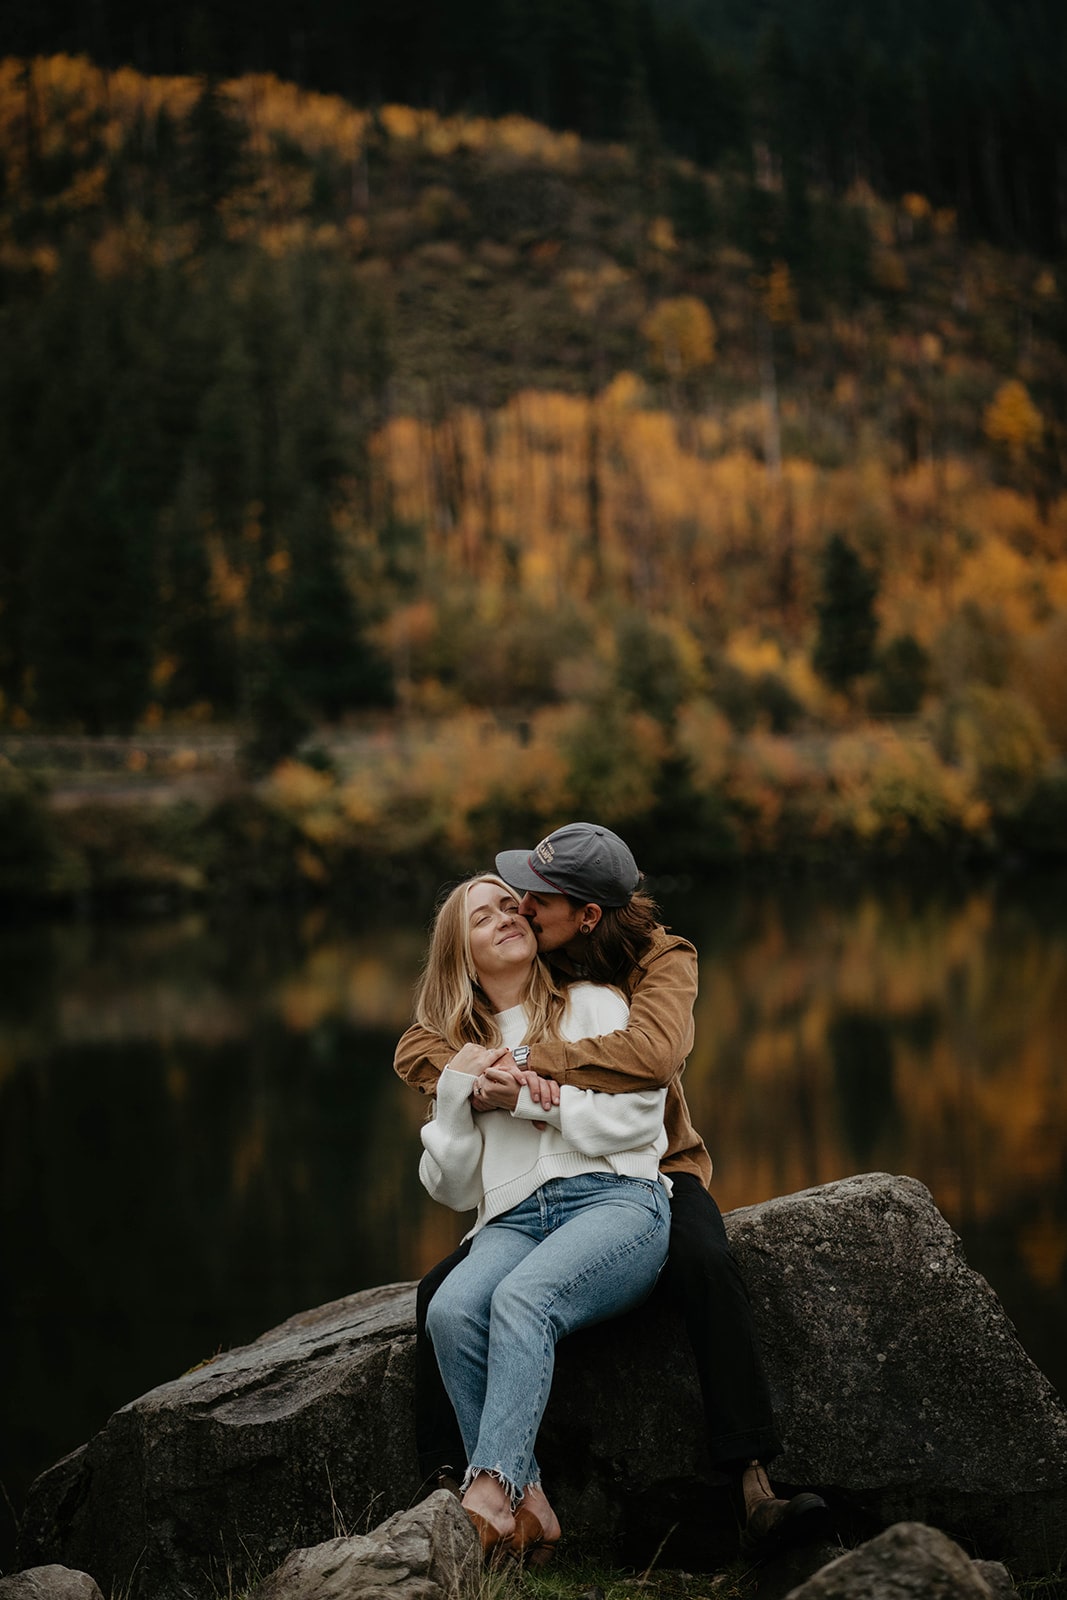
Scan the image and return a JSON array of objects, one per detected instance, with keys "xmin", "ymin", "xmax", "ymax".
[{"xmin": 0, "ymin": 0, "xmax": 1067, "ymax": 253}]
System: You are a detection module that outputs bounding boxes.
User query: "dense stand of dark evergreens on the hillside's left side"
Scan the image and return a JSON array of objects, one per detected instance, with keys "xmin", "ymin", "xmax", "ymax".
[{"xmin": 0, "ymin": 248, "xmax": 389, "ymax": 733}]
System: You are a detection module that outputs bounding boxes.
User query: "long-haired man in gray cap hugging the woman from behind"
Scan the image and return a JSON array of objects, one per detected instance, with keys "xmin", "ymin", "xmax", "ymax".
[{"xmin": 394, "ymin": 822, "xmax": 825, "ymax": 1554}]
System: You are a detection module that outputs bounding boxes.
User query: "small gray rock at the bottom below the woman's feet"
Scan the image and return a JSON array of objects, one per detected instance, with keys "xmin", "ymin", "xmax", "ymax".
[{"xmin": 251, "ymin": 1490, "xmax": 482, "ymax": 1600}]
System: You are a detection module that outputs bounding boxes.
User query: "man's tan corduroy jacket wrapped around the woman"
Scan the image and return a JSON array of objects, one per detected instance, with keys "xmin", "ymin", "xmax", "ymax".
[{"xmin": 394, "ymin": 928, "xmax": 712, "ymax": 1187}]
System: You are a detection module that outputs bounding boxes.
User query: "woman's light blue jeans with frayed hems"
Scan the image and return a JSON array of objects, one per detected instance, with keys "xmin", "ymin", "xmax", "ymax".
[{"xmin": 426, "ymin": 1173, "xmax": 670, "ymax": 1502}]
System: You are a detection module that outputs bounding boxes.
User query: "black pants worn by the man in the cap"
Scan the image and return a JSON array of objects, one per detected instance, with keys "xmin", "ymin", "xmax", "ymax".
[{"xmin": 414, "ymin": 1173, "xmax": 782, "ymax": 1480}]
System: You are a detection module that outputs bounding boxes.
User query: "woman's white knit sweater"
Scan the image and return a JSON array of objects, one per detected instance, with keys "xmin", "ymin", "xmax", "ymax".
[{"xmin": 419, "ymin": 982, "xmax": 670, "ymax": 1237}]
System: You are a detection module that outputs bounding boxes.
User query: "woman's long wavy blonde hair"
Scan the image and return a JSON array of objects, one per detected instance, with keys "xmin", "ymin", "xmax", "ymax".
[{"xmin": 414, "ymin": 872, "xmax": 566, "ymax": 1050}]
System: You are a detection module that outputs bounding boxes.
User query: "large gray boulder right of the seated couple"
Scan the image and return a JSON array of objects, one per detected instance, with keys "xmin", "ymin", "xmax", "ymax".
[{"xmin": 729, "ymin": 1174, "xmax": 1067, "ymax": 1558}]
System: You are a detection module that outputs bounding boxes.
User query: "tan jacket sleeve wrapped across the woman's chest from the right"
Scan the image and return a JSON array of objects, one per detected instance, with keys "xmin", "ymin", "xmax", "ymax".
[{"xmin": 524, "ymin": 939, "xmax": 697, "ymax": 1094}]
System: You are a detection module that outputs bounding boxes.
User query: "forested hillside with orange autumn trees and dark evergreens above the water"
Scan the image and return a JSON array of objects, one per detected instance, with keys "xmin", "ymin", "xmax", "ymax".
[{"xmin": 0, "ymin": 50, "xmax": 1067, "ymax": 883}]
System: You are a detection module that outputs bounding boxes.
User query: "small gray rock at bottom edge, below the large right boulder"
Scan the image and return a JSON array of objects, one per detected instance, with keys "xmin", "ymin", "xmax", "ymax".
[{"xmin": 787, "ymin": 1522, "xmax": 1005, "ymax": 1600}]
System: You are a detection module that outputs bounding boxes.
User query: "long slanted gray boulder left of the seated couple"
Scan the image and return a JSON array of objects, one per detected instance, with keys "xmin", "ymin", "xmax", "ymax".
[{"xmin": 19, "ymin": 1283, "xmax": 418, "ymax": 1600}]
